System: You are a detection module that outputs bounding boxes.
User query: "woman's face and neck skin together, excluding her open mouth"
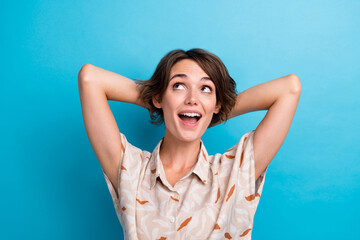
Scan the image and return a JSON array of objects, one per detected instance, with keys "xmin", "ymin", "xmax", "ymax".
[{"xmin": 153, "ymin": 59, "xmax": 220, "ymax": 174}]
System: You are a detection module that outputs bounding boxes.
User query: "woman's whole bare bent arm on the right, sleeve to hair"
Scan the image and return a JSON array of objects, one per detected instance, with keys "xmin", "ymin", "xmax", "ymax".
[{"xmin": 230, "ymin": 74, "xmax": 301, "ymax": 179}]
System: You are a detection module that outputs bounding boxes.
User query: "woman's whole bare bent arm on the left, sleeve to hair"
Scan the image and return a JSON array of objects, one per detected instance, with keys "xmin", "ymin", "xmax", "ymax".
[{"xmin": 78, "ymin": 64, "xmax": 144, "ymax": 195}]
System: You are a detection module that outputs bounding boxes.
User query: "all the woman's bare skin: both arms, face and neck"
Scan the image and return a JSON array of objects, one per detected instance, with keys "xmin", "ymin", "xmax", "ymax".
[{"xmin": 78, "ymin": 60, "xmax": 301, "ymax": 195}]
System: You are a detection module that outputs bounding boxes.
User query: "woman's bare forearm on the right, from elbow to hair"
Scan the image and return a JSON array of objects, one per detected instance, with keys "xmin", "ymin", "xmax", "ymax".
[{"xmin": 230, "ymin": 74, "xmax": 300, "ymax": 118}]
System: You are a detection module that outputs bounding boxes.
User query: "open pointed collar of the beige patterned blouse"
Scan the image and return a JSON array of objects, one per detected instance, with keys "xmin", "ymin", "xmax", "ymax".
[{"xmin": 149, "ymin": 139, "xmax": 210, "ymax": 190}]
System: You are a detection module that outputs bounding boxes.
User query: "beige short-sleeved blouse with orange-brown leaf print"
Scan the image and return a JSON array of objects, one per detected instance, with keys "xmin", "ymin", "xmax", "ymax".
[{"xmin": 103, "ymin": 130, "xmax": 267, "ymax": 240}]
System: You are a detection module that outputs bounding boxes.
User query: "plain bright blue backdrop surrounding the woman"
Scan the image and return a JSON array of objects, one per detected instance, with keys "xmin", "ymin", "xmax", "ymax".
[{"xmin": 0, "ymin": 0, "xmax": 360, "ymax": 240}]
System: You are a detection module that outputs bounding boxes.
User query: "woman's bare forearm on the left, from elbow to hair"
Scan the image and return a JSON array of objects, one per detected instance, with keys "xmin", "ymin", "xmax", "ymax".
[{"xmin": 78, "ymin": 64, "xmax": 144, "ymax": 107}]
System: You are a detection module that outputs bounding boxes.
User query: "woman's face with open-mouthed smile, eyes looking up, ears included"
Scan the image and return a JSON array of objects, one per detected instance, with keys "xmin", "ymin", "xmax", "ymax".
[{"xmin": 153, "ymin": 59, "xmax": 220, "ymax": 142}]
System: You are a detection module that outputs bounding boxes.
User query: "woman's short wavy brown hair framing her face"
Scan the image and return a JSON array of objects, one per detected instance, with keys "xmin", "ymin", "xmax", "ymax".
[{"xmin": 137, "ymin": 48, "xmax": 236, "ymax": 126}]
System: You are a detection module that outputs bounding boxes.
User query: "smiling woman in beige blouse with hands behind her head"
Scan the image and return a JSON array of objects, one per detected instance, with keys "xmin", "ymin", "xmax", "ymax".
[{"xmin": 79, "ymin": 49, "xmax": 301, "ymax": 240}]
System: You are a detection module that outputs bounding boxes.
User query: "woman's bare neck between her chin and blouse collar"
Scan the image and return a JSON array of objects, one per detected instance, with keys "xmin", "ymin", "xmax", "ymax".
[{"xmin": 160, "ymin": 132, "xmax": 201, "ymax": 172}]
